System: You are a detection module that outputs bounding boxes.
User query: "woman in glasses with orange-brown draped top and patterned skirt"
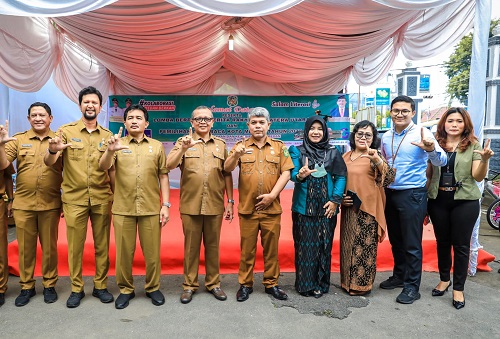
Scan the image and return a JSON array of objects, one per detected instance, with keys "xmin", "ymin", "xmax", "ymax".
[{"xmin": 340, "ymin": 120, "xmax": 388, "ymax": 295}]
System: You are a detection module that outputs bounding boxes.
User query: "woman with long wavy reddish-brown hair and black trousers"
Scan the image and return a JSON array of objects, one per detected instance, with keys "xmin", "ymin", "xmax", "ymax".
[{"xmin": 427, "ymin": 107, "xmax": 494, "ymax": 309}]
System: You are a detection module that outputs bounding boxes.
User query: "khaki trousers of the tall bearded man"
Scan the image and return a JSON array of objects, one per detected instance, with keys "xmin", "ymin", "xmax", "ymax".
[{"xmin": 63, "ymin": 203, "xmax": 111, "ymax": 293}]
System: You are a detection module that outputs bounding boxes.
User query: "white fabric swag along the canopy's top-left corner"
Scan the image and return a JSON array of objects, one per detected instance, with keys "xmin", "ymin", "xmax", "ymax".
[{"xmin": 0, "ymin": 0, "xmax": 117, "ymax": 17}]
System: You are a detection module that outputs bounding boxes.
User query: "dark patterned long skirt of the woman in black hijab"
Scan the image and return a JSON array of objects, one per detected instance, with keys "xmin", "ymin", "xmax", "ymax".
[{"xmin": 292, "ymin": 212, "xmax": 337, "ymax": 293}]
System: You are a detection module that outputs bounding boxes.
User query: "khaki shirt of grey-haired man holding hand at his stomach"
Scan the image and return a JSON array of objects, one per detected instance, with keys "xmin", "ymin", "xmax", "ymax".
[{"xmin": 230, "ymin": 137, "xmax": 294, "ymax": 214}]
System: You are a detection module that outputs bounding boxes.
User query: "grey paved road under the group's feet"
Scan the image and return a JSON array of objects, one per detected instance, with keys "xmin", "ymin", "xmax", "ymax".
[{"xmin": 0, "ymin": 211, "xmax": 500, "ymax": 338}]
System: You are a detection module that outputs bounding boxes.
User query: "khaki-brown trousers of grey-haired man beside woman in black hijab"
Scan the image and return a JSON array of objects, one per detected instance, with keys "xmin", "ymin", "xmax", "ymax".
[{"xmin": 238, "ymin": 212, "xmax": 281, "ymax": 287}]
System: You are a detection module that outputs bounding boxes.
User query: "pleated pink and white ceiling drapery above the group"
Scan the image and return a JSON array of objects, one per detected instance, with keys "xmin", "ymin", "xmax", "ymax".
[{"xmin": 0, "ymin": 0, "xmax": 475, "ymax": 101}]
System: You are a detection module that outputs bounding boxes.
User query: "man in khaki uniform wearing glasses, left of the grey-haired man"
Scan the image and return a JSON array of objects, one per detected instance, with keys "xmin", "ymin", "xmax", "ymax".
[{"xmin": 167, "ymin": 106, "xmax": 234, "ymax": 304}]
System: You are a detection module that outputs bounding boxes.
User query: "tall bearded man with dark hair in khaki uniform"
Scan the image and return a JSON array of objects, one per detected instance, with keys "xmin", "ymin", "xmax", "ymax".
[{"xmin": 44, "ymin": 86, "xmax": 114, "ymax": 308}]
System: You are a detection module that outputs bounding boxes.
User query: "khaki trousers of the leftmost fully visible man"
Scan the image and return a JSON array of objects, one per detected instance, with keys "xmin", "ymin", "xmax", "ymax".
[{"xmin": 14, "ymin": 208, "xmax": 61, "ymax": 290}]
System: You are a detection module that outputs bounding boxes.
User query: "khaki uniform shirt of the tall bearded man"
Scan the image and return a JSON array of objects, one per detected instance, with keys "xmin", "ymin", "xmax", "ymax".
[{"xmin": 61, "ymin": 119, "xmax": 113, "ymax": 206}]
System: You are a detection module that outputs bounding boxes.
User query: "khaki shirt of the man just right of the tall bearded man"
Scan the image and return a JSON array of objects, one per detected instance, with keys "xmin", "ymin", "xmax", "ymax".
[{"xmin": 112, "ymin": 135, "xmax": 168, "ymax": 216}]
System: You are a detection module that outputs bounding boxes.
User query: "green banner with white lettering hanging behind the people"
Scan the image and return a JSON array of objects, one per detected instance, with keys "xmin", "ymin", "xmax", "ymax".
[{"xmin": 108, "ymin": 94, "xmax": 350, "ymax": 145}]
